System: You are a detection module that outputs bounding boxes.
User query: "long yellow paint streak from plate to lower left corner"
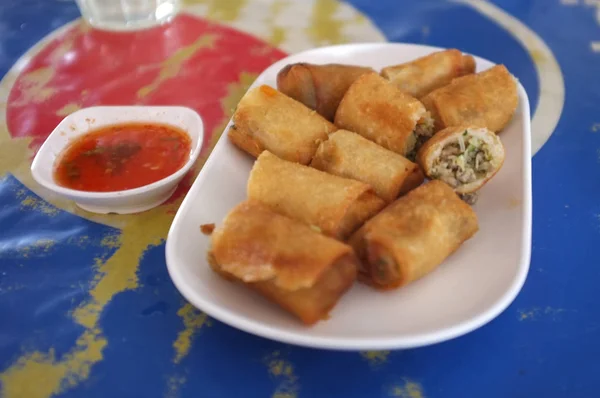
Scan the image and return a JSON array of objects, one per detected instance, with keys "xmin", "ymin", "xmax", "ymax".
[{"xmin": 0, "ymin": 199, "xmax": 180, "ymax": 398}]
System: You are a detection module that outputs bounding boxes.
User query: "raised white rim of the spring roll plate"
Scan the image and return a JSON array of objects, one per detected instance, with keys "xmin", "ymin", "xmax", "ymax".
[{"xmin": 165, "ymin": 43, "xmax": 532, "ymax": 351}]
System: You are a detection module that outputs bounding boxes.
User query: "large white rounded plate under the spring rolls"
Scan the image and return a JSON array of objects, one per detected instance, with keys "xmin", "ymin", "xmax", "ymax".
[{"xmin": 166, "ymin": 43, "xmax": 531, "ymax": 350}]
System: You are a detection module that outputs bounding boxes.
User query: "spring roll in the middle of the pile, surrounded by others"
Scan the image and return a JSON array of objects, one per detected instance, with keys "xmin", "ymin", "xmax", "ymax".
[{"xmin": 311, "ymin": 130, "xmax": 424, "ymax": 202}]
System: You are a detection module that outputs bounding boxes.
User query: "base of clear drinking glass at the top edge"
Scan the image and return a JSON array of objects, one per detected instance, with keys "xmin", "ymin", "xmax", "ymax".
[{"xmin": 77, "ymin": 0, "xmax": 180, "ymax": 30}]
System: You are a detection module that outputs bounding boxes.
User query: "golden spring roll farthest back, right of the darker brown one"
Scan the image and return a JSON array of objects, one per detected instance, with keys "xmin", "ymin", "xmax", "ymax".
[{"xmin": 381, "ymin": 49, "xmax": 475, "ymax": 98}]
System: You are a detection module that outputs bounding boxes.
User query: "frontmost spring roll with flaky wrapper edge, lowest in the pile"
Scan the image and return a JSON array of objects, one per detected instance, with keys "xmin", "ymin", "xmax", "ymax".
[{"xmin": 209, "ymin": 201, "xmax": 358, "ymax": 325}]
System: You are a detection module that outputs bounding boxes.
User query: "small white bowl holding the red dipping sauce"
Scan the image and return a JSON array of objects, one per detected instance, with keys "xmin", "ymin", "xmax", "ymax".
[{"xmin": 31, "ymin": 106, "xmax": 204, "ymax": 214}]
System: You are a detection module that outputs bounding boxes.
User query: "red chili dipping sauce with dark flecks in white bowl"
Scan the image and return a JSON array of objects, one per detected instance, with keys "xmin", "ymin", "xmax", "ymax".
[{"xmin": 54, "ymin": 123, "xmax": 192, "ymax": 192}]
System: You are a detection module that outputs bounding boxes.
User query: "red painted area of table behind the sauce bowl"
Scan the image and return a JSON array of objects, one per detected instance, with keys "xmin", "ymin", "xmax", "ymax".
[{"xmin": 6, "ymin": 14, "xmax": 286, "ymax": 199}]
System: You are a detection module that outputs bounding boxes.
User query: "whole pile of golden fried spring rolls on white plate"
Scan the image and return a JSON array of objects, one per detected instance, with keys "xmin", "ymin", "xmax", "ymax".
[{"xmin": 208, "ymin": 49, "xmax": 518, "ymax": 325}]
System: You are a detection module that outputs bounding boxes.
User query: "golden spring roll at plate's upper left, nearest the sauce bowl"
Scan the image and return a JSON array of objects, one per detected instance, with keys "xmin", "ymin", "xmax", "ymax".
[{"xmin": 228, "ymin": 85, "xmax": 336, "ymax": 164}]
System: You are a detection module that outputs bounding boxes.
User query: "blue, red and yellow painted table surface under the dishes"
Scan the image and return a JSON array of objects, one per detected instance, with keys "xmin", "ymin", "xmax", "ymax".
[{"xmin": 0, "ymin": 0, "xmax": 600, "ymax": 398}]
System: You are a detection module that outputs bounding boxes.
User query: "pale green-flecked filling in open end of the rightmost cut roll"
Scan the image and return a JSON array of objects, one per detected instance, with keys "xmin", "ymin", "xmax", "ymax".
[{"xmin": 432, "ymin": 131, "xmax": 493, "ymax": 188}]
